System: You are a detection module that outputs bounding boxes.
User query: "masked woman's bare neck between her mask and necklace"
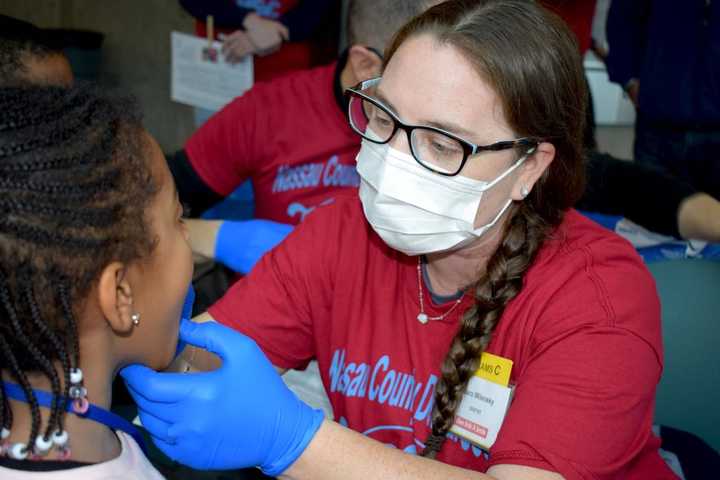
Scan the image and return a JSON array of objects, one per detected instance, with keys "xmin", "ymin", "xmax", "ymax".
[{"xmin": 426, "ymin": 222, "xmax": 505, "ymax": 295}]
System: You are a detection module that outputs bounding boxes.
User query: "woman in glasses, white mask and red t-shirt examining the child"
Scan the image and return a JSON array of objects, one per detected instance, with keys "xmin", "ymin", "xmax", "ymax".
[{"xmin": 119, "ymin": 0, "xmax": 674, "ymax": 479}]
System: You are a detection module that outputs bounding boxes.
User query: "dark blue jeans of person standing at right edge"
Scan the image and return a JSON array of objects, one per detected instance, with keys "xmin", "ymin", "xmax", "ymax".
[{"xmin": 635, "ymin": 113, "xmax": 720, "ymax": 198}]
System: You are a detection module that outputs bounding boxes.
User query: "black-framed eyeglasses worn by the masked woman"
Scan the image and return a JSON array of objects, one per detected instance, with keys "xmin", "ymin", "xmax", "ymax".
[{"xmin": 346, "ymin": 77, "xmax": 540, "ymax": 177}]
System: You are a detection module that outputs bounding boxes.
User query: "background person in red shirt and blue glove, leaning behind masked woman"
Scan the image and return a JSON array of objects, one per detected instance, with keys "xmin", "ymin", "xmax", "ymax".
[{"xmin": 169, "ymin": 0, "xmax": 432, "ymax": 273}]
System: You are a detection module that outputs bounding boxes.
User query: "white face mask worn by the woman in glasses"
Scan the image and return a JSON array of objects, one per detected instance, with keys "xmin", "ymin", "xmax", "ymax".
[{"xmin": 357, "ymin": 140, "xmax": 530, "ymax": 255}]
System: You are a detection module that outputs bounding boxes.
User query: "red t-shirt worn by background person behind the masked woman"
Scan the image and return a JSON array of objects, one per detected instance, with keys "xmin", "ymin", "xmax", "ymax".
[{"xmin": 185, "ymin": 64, "xmax": 360, "ymax": 224}]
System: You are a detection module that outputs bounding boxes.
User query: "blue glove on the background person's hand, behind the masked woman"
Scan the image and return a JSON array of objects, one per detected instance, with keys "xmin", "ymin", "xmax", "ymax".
[{"xmin": 215, "ymin": 219, "xmax": 293, "ymax": 274}]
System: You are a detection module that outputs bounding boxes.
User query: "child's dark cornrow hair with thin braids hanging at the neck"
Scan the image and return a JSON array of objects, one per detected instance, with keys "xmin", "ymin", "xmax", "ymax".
[{"xmin": 0, "ymin": 86, "xmax": 157, "ymax": 454}]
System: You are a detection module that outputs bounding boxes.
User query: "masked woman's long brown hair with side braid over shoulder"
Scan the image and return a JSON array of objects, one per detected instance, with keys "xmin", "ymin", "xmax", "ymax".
[{"xmin": 385, "ymin": 0, "xmax": 587, "ymax": 458}]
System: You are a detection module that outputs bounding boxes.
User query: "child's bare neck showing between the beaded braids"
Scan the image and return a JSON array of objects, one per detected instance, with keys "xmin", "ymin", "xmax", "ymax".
[{"xmin": 2, "ymin": 366, "xmax": 121, "ymax": 463}]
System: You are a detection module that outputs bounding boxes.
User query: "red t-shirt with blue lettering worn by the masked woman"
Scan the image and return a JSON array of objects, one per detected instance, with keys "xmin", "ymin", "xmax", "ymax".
[{"xmin": 210, "ymin": 198, "xmax": 675, "ymax": 479}]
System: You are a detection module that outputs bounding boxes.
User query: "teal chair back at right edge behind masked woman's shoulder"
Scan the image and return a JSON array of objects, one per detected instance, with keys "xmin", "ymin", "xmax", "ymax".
[{"xmin": 648, "ymin": 259, "xmax": 720, "ymax": 451}]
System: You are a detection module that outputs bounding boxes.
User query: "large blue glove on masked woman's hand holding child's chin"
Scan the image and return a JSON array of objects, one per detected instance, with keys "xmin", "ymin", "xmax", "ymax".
[{"xmin": 120, "ymin": 320, "xmax": 324, "ymax": 476}]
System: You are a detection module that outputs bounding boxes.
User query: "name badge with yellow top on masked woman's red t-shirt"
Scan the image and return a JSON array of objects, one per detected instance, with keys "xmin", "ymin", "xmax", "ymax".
[{"xmin": 450, "ymin": 352, "xmax": 514, "ymax": 450}]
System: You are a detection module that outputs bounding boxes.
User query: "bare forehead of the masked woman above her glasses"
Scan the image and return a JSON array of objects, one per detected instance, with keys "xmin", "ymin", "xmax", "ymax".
[{"xmin": 378, "ymin": 35, "xmax": 512, "ymax": 143}]
